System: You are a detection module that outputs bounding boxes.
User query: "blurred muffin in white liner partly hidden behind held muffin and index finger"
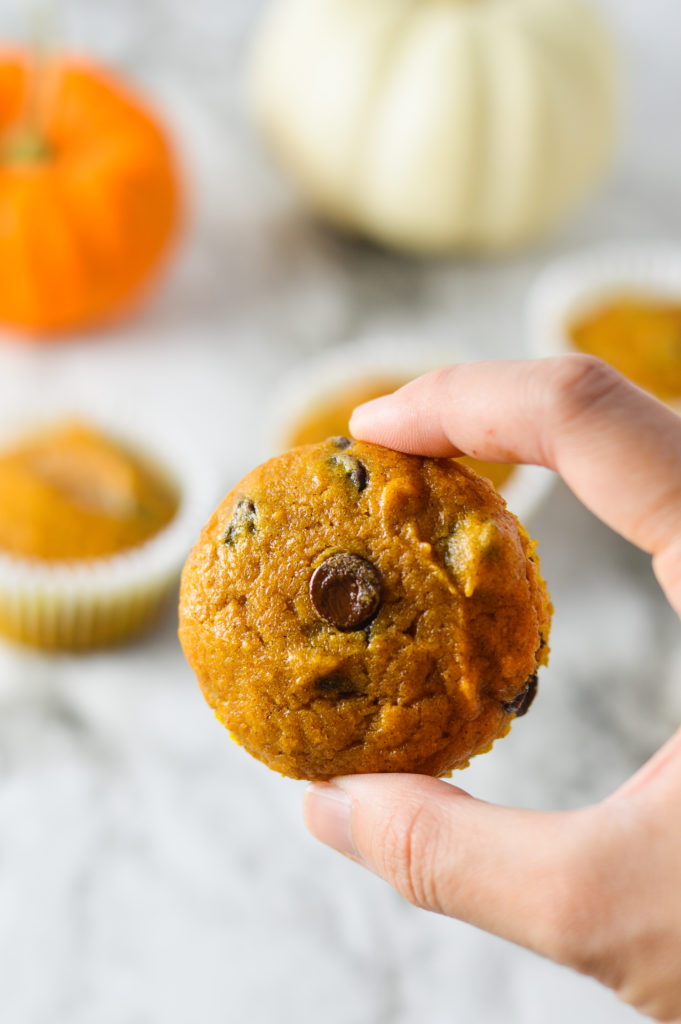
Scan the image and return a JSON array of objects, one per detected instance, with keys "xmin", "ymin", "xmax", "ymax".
[{"xmin": 263, "ymin": 337, "xmax": 553, "ymax": 518}]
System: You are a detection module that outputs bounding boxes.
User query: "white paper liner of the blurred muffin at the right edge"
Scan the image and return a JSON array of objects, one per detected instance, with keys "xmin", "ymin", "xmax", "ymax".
[{"xmin": 526, "ymin": 242, "xmax": 681, "ymax": 374}]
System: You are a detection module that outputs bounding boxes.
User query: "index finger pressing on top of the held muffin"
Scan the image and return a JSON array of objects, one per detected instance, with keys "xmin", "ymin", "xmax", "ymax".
[{"xmin": 350, "ymin": 355, "xmax": 681, "ymax": 613}]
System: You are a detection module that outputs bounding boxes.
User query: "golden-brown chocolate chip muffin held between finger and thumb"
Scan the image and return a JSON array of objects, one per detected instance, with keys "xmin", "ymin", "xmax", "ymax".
[{"xmin": 180, "ymin": 437, "xmax": 552, "ymax": 779}]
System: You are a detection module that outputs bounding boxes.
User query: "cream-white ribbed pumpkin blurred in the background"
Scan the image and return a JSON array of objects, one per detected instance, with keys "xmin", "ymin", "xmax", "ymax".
[{"xmin": 252, "ymin": 0, "xmax": 618, "ymax": 253}]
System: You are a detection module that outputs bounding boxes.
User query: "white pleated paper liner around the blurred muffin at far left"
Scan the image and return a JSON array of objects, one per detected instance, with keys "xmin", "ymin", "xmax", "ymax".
[{"xmin": 0, "ymin": 409, "xmax": 217, "ymax": 649}]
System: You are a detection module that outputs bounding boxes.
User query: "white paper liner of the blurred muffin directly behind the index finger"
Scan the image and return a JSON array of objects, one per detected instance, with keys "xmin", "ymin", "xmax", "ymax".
[{"xmin": 263, "ymin": 335, "xmax": 556, "ymax": 522}]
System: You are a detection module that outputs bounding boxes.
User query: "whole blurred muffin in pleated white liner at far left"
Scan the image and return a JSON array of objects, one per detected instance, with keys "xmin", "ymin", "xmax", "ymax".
[{"xmin": 0, "ymin": 419, "xmax": 213, "ymax": 649}]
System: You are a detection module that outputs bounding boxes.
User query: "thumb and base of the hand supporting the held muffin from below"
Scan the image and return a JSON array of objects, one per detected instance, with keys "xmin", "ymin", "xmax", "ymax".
[{"xmin": 304, "ymin": 775, "xmax": 681, "ymax": 1022}]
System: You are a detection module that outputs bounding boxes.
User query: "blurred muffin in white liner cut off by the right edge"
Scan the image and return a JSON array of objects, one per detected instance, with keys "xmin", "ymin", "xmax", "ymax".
[{"xmin": 527, "ymin": 243, "xmax": 681, "ymax": 409}]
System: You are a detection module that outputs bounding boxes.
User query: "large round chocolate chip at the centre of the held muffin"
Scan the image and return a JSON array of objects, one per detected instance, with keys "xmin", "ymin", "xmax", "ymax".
[{"xmin": 309, "ymin": 551, "xmax": 381, "ymax": 631}]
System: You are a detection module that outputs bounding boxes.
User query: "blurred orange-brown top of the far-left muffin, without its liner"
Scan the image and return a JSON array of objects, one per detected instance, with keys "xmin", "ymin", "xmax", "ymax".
[{"xmin": 0, "ymin": 422, "xmax": 178, "ymax": 561}]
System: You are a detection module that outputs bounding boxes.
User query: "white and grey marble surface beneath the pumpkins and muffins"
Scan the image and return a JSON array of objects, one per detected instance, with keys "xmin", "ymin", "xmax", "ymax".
[{"xmin": 0, "ymin": 0, "xmax": 681, "ymax": 1024}]
